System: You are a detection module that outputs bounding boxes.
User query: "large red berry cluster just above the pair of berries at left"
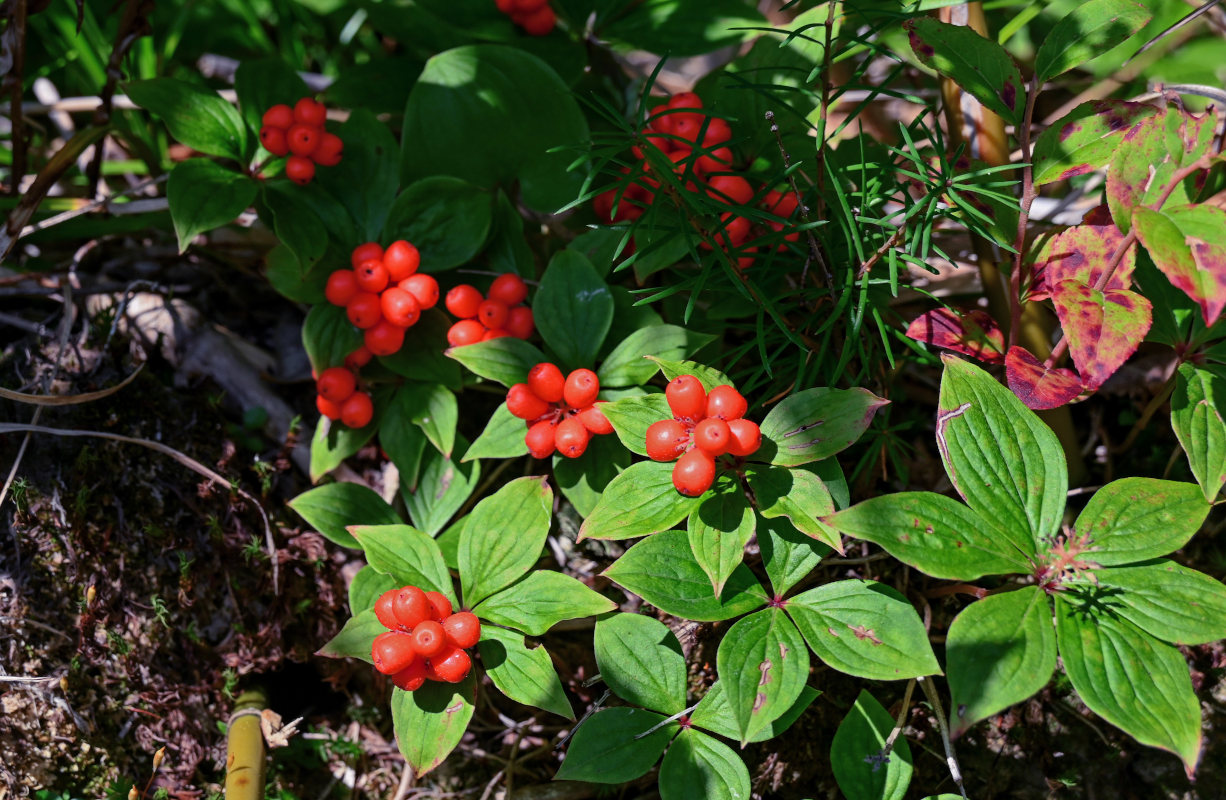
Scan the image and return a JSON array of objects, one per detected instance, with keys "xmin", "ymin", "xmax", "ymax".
[{"xmin": 324, "ymin": 239, "xmax": 439, "ymax": 357}]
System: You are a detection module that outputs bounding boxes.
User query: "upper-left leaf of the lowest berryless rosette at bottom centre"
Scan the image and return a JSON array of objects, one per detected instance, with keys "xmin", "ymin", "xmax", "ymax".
[{"xmin": 592, "ymin": 614, "xmax": 687, "ymax": 715}]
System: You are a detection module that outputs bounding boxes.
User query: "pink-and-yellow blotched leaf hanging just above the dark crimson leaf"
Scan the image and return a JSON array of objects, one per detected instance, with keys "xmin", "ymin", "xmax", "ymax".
[{"xmin": 1052, "ymin": 281, "xmax": 1154, "ymax": 392}]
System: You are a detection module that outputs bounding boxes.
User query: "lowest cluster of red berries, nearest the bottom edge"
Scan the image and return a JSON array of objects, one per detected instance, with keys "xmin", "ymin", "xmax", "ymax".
[{"xmin": 370, "ymin": 586, "xmax": 481, "ymax": 692}]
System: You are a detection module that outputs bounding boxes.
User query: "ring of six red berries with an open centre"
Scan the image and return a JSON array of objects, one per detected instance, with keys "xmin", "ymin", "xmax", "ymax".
[{"xmin": 506, "ymin": 361, "xmax": 613, "ymax": 458}]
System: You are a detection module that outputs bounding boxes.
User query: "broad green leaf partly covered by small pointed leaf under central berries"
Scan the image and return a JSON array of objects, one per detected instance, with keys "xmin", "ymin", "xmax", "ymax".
[{"xmin": 604, "ymin": 526, "xmax": 766, "ymax": 622}]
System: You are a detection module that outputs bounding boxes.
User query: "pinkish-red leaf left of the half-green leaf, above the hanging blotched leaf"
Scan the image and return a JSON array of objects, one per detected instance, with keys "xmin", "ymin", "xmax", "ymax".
[{"xmin": 1029, "ymin": 206, "xmax": 1137, "ymax": 300}]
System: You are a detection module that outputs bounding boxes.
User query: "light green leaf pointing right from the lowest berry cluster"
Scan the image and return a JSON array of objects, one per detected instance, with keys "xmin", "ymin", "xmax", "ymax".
[{"xmin": 473, "ymin": 570, "xmax": 617, "ymax": 636}]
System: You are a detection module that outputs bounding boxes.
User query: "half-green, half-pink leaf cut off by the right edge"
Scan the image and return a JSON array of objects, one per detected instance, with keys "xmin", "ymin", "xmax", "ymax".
[{"xmin": 1133, "ymin": 206, "xmax": 1226, "ymax": 325}]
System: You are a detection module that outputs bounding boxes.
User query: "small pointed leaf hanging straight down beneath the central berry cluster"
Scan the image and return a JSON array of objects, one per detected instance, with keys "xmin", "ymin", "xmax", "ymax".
[{"xmin": 687, "ymin": 480, "xmax": 756, "ymax": 597}]
